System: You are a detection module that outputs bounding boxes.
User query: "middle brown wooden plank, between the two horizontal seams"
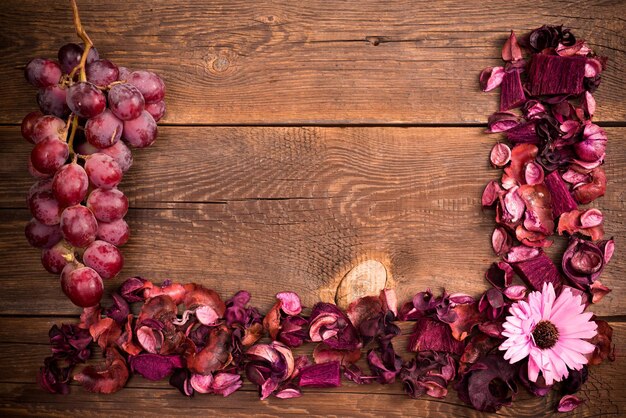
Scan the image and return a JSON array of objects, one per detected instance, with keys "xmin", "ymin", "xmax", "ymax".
[{"xmin": 0, "ymin": 127, "xmax": 626, "ymax": 315}]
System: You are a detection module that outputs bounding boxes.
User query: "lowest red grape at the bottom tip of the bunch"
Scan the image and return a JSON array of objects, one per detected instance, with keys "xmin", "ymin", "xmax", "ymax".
[{"xmin": 61, "ymin": 264, "xmax": 104, "ymax": 308}]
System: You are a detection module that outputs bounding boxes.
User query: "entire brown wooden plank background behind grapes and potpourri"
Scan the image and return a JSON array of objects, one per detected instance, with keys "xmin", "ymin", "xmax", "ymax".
[{"xmin": 0, "ymin": 0, "xmax": 626, "ymax": 417}]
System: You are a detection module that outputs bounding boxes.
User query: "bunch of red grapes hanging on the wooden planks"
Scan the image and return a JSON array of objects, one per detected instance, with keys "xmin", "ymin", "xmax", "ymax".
[{"xmin": 22, "ymin": 43, "xmax": 165, "ymax": 307}]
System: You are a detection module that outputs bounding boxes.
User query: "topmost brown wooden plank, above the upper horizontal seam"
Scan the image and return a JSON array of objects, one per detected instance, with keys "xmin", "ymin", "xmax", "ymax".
[{"xmin": 0, "ymin": 0, "xmax": 626, "ymax": 124}]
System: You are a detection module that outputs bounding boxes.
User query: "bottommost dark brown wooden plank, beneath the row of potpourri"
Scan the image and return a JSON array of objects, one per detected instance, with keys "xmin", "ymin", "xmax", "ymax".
[{"xmin": 0, "ymin": 317, "xmax": 626, "ymax": 416}]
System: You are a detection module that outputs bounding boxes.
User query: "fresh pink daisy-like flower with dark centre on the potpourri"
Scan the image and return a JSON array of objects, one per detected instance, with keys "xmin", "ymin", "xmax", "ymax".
[{"xmin": 500, "ymin": 283, "xmax": 598, "ymax": 385}]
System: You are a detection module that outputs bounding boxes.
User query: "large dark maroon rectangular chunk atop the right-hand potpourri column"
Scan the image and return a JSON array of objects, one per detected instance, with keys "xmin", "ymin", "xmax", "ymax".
[{"xmin": 528, "ymin": 54, "xmax": 587, "ymax": 96}]
